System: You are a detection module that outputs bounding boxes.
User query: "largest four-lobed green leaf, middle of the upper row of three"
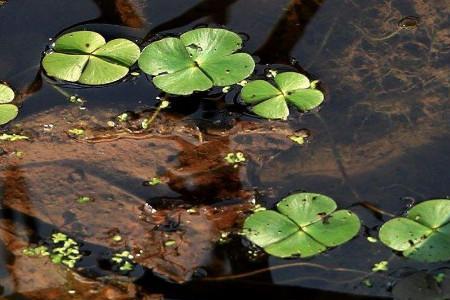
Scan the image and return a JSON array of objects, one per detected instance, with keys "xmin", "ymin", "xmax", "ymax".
[{"xmin": 139, "ymin": 28, "xmax": 255, "ymax": 95}]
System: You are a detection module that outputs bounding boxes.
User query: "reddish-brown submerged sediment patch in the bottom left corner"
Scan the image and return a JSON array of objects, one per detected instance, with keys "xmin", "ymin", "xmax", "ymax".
[{"xmin": 0, "ymin": 219, "xmax": 162, "ymax": 300}]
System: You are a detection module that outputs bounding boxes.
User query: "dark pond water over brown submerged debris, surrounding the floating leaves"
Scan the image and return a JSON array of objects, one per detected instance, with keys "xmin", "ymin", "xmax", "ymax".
[{"xmin": 0, "ymin": 0, "xmax": 450, "ymax": 299}]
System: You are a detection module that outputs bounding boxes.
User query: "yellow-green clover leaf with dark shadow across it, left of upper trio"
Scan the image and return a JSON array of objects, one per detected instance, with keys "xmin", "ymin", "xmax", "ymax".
[{"xmin": 42, "ymin": 31, "xmax": 140, "ymax": 85}]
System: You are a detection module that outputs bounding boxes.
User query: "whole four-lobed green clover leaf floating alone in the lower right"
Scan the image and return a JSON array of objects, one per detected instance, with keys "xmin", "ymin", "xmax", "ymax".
[{"xmin": 244, "ymin": 193, "xmax": 361, "ymax": 258}]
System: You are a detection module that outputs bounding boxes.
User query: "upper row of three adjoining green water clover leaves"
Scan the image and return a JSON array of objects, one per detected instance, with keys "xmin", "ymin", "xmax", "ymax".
[{"xmin": 38, "ymin": 28, "xmax": 324, "ymax": 120}]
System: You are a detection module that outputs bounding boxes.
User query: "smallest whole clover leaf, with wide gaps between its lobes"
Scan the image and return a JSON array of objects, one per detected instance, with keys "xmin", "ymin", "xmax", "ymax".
[{"xmin": 241, "ymin": 72, "xmax": 324, "ymax": 120}]
